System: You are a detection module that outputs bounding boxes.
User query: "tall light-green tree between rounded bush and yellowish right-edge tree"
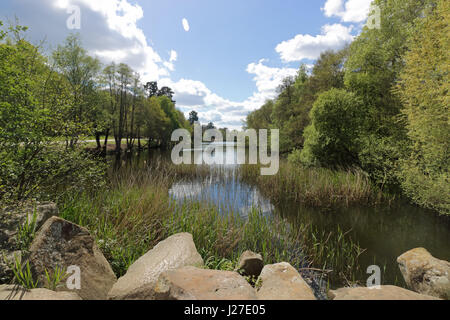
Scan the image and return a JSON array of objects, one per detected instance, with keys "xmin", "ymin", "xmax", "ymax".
[{"xmin": 344, "ymin": 0, "xmax": 435, "ymax": 188}]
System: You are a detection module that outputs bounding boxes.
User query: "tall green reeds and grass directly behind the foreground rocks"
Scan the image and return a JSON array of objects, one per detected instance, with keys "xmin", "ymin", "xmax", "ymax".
[{"xmin": 61, "ymin": 161, "xmax": 362, "ymax": 283}]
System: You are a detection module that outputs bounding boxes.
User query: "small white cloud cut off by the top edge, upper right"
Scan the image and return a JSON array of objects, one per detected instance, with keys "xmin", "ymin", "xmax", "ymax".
[{"xmin": 322, "ymin": 0, "xmax": 372, "ymax": 22}]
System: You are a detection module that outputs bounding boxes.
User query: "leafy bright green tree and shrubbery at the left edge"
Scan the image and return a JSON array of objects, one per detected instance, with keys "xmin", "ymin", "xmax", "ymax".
[{"xmin": 0, "ymin": 23, "xmax": 103, "ymax": 203}]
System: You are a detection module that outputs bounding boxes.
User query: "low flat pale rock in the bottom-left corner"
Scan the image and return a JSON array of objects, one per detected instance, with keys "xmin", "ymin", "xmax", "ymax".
[{"xmin": 0, "ymin": 285, "xmax": 81, "ymax": 301}]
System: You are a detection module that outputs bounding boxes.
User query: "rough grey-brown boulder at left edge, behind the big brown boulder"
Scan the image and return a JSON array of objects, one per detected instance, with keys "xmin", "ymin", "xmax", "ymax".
[{"xmin": 0, "ymin": 203, "xmax": 59, "ymax": 284}]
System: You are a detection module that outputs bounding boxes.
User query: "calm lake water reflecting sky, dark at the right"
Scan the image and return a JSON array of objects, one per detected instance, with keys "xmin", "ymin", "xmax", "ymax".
[{"xmin": 110, "ymin": 145, "xmax": 450, "ymax": 286}]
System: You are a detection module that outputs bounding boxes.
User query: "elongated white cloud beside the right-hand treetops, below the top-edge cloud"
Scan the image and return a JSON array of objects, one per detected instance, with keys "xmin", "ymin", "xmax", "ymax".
[{"xmin": 275, "ymin": 24, "xmax": 354, "ymax": 62}]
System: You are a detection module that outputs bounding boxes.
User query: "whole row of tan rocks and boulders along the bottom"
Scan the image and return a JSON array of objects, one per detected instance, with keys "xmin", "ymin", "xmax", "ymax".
[{"xmin": 0, "ymin": 204, "xmax": 450, "ymax": 300}]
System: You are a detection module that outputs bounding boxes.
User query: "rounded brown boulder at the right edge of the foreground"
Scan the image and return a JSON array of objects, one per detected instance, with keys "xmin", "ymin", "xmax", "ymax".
[{"xmin": 397, "ymin": 248, "xmax": 450, "ymax": 300}]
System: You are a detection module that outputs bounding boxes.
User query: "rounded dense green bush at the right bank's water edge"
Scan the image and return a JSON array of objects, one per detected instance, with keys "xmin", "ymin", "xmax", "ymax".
[{"xmin": 300, "ymin": 89, "xmax": 363, "ymax": 167}]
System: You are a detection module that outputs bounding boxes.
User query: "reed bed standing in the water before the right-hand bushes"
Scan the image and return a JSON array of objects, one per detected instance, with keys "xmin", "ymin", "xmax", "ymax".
[{"xmin": 240, "ymin": 161, "xmax": 387, "ymax": 208}]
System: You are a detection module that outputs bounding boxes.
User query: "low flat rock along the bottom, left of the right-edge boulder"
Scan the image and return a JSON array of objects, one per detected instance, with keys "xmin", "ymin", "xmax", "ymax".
[{"xmin": 328, "ymin": 286, "xmax": 439, "ymax": 300}]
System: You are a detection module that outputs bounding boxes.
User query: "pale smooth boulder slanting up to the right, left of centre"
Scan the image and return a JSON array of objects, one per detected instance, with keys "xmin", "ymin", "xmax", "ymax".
[{"xmin": 108, "ymin": 233, "xmax": 203, "ymax": 300}]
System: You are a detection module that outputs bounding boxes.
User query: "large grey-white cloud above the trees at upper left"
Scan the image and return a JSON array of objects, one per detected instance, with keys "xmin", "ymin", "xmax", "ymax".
[{"xmin": 8, "ymin": 0, "xmax": 175, "ymax": 81}]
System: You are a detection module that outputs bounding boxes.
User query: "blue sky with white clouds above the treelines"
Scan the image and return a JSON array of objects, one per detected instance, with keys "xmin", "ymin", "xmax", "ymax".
[{"xmin": 0, "ymin": 0, "xmax": 371, "ymax": 129}]
